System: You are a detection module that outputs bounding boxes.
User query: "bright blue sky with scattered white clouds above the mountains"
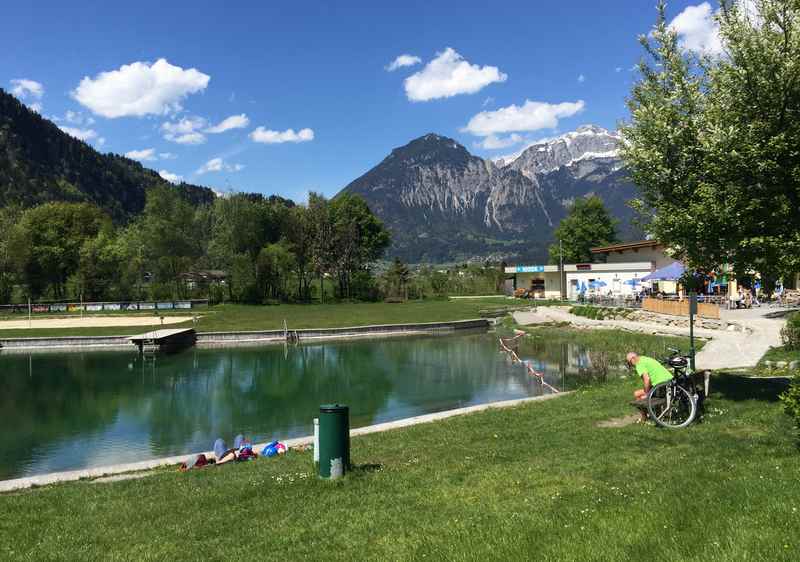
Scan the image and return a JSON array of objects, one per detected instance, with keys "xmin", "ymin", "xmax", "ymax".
[{"xmin": 0, "ymin": 0, "xmax": 716, "ymax": 199}]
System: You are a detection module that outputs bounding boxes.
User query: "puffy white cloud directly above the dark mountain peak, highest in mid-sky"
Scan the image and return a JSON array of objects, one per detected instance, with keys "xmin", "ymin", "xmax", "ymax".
[{"xmin": 405, "ymin": 47, "xmax": 508, "ymax": 101}]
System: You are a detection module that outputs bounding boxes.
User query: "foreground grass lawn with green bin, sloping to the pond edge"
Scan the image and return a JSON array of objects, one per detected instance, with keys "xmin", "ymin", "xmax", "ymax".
[{"xmin": 0, "ymin": 370, "xmax": 800, "ymax": 562}]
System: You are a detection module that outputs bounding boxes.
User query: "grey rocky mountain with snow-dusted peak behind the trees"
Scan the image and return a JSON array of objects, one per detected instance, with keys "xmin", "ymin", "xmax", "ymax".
[{"xmin": 343, "ymin": 125, "xmax": 637, "ymax": 263}]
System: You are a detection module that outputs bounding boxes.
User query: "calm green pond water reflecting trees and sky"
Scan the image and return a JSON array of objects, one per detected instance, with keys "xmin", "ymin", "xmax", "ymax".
[{"xmin": 0, "ymin": 333, "xmax": 581, "ymax": 479}]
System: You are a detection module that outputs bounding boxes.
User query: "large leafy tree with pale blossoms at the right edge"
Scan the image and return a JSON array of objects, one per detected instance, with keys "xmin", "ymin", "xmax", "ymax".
[{"xmin": 622, "ymin": 0, "xmax": 800, "ymax": 277}]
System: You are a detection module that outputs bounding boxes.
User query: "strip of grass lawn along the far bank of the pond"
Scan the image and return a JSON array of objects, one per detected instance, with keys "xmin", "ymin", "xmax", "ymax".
[{"xmin": 0, "ymin": 297, "xmax": 533, "ymax": 338}]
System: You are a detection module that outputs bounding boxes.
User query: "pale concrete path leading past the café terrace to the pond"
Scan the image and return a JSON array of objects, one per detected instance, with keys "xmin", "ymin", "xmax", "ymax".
[{"xmin": 514, "ymin": 306, "xmax": 787, "ymax": 370}]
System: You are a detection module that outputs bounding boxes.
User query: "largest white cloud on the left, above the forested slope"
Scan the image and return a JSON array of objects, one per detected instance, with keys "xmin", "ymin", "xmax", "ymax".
[{"xmin": 72, "ymin": 59, "xmax": 211, "ymax": 118}]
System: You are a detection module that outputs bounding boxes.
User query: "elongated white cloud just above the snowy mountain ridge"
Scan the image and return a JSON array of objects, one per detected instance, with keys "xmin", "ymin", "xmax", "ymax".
[{"xmin": 462, "ymin": 100, "xmax": 585, "ymax": 137}]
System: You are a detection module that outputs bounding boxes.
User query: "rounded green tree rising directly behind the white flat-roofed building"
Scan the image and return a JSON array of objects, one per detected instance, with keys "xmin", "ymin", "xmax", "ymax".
[{"xmin": 550, "ymin": 196, "xmax": 618, "ymax": 264}]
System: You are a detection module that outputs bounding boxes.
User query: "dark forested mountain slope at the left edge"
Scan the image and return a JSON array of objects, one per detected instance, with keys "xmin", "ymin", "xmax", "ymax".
[{"xmin": 0, "ymin": 89, "xmax": 214, "ymax": 222}]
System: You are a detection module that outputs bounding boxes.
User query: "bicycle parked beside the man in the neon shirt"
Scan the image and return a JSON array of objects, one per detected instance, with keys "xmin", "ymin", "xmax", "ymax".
[{"xmin": 647, "ymin": 348, "xmax": 705, "ymax": 429}]
